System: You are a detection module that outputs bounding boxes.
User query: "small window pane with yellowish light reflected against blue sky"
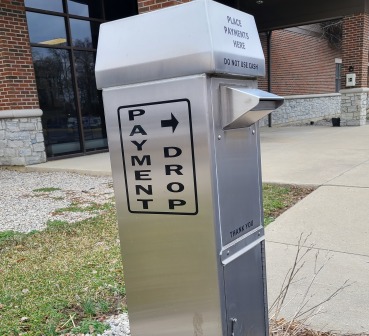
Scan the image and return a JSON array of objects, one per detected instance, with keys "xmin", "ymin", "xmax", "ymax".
[{"xmin": 27, "ymin": 12, "xmax": 67, "ymax": 46}]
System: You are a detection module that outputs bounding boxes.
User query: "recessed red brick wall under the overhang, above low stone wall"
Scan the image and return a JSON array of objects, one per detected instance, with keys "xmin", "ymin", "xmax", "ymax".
[{"xmin": 259, "ymin": 30, "xmax": 341, "ymax": 95}]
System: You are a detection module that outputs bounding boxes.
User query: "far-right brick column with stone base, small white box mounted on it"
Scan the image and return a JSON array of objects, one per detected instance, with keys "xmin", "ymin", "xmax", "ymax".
[{"xmin": 340, "ymin": 13, "xmax": 369, "ymax": 126}]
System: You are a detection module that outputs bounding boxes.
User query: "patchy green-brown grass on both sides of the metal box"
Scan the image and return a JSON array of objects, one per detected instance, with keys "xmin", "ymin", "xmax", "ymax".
[{"xmin": 0, "ymin": 185, "xmax": 312, "ymax": 336}]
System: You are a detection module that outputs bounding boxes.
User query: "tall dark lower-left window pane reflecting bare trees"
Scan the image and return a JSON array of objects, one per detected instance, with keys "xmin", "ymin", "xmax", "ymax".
[{"xmin": 32, "ymin": 48, "xmax": 81, "ymax": 156}]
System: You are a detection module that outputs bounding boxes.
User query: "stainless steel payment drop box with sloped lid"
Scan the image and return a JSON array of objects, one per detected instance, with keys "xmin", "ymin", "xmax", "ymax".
[{"xmin": 96, "ymin": 0, "xmax": 283, "ymax": 336}]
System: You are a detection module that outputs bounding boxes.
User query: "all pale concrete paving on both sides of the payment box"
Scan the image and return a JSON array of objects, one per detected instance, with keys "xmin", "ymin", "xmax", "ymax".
[{"xmin": 27, "ymin": 126, "xmax": 369, "ymax": 333}]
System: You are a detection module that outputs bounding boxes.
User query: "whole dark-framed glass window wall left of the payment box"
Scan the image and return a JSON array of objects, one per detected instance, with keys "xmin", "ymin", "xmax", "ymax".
[{"xmin": 25, "ymin": 0, "xmax": 108, "ymax": 158}]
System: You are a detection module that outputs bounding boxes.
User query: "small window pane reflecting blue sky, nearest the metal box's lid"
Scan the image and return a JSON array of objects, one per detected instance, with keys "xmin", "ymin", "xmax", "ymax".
[{"xmin": 70, "ymin": 19, "xmax": 99, "ymax": 48}]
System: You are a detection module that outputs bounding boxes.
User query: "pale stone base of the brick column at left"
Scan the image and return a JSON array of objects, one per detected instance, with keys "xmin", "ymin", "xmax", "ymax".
[{"xmin": 0, "ymin": 109, "xmax": 46, "ymax": 166}]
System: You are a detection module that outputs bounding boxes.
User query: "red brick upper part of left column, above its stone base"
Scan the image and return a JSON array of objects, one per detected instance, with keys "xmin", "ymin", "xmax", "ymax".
[{"xmin": 0, "ymin": 0, "xmax": 39, "ymax": 113}]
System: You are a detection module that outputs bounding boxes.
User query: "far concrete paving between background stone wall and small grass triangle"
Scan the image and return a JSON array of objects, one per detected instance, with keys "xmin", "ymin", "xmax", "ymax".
[{"xmin": 261, "ymin": 125, "xmax": 369, "ymax": 186}]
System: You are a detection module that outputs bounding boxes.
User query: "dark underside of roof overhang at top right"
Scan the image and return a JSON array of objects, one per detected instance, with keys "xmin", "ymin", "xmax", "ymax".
[{"xmin": 220, "ymin": 0, "xmax": 369, "ymax": 32}]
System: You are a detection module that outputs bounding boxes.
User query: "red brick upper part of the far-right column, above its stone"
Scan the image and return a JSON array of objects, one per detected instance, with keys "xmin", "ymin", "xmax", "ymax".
[{"xmin": 341, "ymin": 14, "xmax": 369, "ymax": 88}]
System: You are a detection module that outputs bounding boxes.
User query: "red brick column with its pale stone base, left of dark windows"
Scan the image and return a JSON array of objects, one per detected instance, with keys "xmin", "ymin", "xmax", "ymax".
[{"xmin": 0, "ymin": 0, "xmax": 46, "ymax": 165}]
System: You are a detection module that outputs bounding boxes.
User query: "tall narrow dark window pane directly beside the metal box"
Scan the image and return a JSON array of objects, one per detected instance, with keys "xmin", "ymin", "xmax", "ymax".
[{"xmin": 74, "ymin": 51, "xmax": 108, "ymax": 151}]
